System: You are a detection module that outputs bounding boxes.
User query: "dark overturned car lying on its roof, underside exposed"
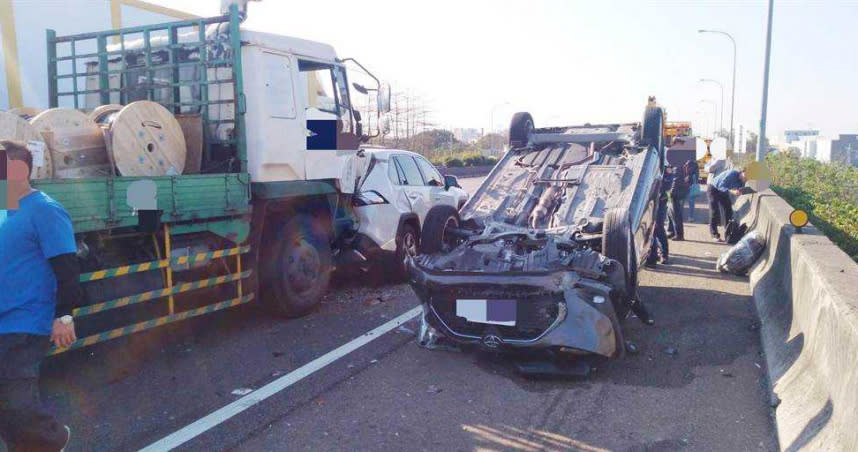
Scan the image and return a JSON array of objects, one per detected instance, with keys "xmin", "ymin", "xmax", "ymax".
[{"xmin": 409, "ymin": 98, "xmax": 664, "ymax": 357}]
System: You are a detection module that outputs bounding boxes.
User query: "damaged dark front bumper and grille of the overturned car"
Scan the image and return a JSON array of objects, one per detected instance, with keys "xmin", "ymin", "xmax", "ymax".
[{"xmin": 409, "ymin": 260, "xmax": 625, "ymax": 358}]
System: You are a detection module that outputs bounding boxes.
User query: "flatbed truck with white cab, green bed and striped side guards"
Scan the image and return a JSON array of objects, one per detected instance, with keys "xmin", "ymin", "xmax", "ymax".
[{"xmin": 34, "ymin": 5, "xmax": 389, "ymax": 353}]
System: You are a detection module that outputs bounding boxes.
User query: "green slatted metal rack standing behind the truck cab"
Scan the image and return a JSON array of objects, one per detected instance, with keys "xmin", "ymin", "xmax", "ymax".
[{"xmin": 47, "ymin": 5, "xmax": 247, "ymax": 172}]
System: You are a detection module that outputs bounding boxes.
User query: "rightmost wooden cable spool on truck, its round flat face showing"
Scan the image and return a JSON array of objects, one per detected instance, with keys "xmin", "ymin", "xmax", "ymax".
[{"xmin": 110, "ymin": 100, "xmax": 187, "ymax": 176}]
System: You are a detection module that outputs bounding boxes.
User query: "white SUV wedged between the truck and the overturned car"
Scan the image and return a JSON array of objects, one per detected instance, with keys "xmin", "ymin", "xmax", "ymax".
[{"xmin": 355, "ymin": 149, "xmax": 469, "ymax": 277}]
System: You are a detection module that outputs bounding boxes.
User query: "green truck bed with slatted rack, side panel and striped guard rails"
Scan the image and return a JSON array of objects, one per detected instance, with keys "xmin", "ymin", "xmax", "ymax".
[{"xmin": 34, "ymin": 5, "xmax": 254, "ymax": 355}]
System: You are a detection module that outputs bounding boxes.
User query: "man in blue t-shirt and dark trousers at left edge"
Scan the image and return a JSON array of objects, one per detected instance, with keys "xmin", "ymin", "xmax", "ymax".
[{"xmin": 0, "ymin": 141, "xmax": 81, "ymax": 451}]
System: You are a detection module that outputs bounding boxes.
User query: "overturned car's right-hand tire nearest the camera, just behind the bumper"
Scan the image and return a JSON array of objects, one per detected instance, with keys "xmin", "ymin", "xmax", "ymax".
[{"xmin": 602, "ymin": 209, "xmax": 638, "ymax": 302}]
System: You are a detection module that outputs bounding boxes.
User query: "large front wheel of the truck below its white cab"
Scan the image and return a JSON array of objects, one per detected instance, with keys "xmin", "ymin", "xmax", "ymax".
[{"xmin": 262, "ymin": 214, "xmax": 332, "ymax": 317}]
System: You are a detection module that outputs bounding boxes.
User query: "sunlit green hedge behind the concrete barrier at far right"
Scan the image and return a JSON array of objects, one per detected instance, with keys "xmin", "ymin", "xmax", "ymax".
[{"xmin": 766, "ymin": 153, "xmax": 858, "ymax": 261}]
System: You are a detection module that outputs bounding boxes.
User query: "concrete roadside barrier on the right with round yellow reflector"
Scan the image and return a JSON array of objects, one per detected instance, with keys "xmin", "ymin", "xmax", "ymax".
[{"xmin": 735, "ymin": 190, "xmax": 858, "ymax": 451}]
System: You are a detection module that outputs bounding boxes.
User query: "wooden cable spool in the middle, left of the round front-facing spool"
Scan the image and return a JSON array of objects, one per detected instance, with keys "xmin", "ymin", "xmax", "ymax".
[{"xmin": 30, "ymin": 108, "xmax": 112, "ymax": 179}]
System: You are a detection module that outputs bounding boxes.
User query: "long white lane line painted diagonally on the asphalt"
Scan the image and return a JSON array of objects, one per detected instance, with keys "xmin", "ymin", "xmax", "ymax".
[{"xmin": 141, "ymin": 306, "xmax": 421, "ymax": 452}]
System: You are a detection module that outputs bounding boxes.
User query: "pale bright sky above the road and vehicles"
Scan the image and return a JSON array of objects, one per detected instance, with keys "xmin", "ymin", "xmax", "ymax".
[{"xmin": 152, "ymin": 0, "xmax": 858, "ymax": 139}]
